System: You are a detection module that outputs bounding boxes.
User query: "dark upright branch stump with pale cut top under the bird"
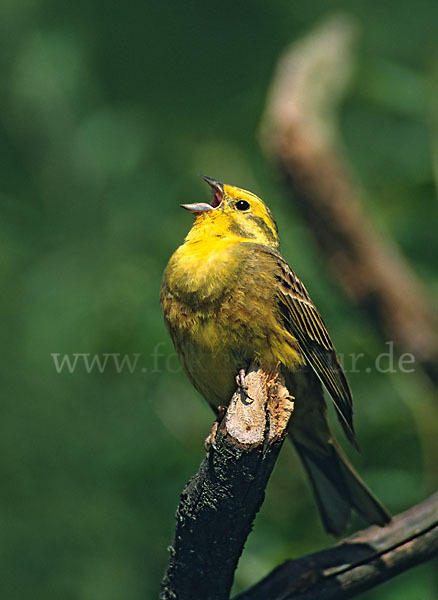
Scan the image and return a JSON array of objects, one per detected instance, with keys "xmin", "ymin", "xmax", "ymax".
[{"xmin": 160, "ymin": 370, "xmax": 293, "ymax": 600}]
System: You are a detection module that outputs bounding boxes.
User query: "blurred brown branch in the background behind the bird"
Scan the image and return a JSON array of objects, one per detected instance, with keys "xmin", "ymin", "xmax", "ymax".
[{"xmin": 262, "ymin": 17, "xmax": 438, "ymax": 383}]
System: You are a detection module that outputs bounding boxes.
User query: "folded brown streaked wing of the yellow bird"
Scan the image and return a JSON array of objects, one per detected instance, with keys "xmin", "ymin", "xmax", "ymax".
[{"xmin": 275, "ymin": 255, "xmax": 357, "ymax": 447}]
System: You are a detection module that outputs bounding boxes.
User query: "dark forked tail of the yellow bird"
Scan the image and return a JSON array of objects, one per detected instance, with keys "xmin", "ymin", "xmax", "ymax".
[{"xmin": 290, "ymin": 432, "xmax": 391, "ymax": 536}]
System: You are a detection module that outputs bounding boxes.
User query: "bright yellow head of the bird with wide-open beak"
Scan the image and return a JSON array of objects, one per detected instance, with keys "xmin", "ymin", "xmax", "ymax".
[{"xmin": 181, "ymin": 175, "xmax": 279, "ymax": 249}]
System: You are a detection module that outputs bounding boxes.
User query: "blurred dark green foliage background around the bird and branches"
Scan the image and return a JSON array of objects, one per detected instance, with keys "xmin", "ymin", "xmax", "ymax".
[{"xmin": 0, "ymin": 0, "xmax": 438, "ymax": 600}]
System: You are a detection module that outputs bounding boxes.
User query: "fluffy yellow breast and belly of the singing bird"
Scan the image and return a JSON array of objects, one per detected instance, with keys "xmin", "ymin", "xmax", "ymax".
[{"xmin": 161, "ymin": 238, "xmax": 302, "ymax": 405}]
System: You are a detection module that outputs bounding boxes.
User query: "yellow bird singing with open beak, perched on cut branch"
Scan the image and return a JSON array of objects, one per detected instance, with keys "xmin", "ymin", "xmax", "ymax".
[{"xmin": 161, "ymin": 177, "xmax": 390, "ymax": 535}]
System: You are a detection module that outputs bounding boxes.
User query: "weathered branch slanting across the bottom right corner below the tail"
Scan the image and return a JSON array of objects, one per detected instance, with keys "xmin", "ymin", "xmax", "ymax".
[{"xmin": 234, "ymin": 494, "xmax": 438, "ymax": 600}]
